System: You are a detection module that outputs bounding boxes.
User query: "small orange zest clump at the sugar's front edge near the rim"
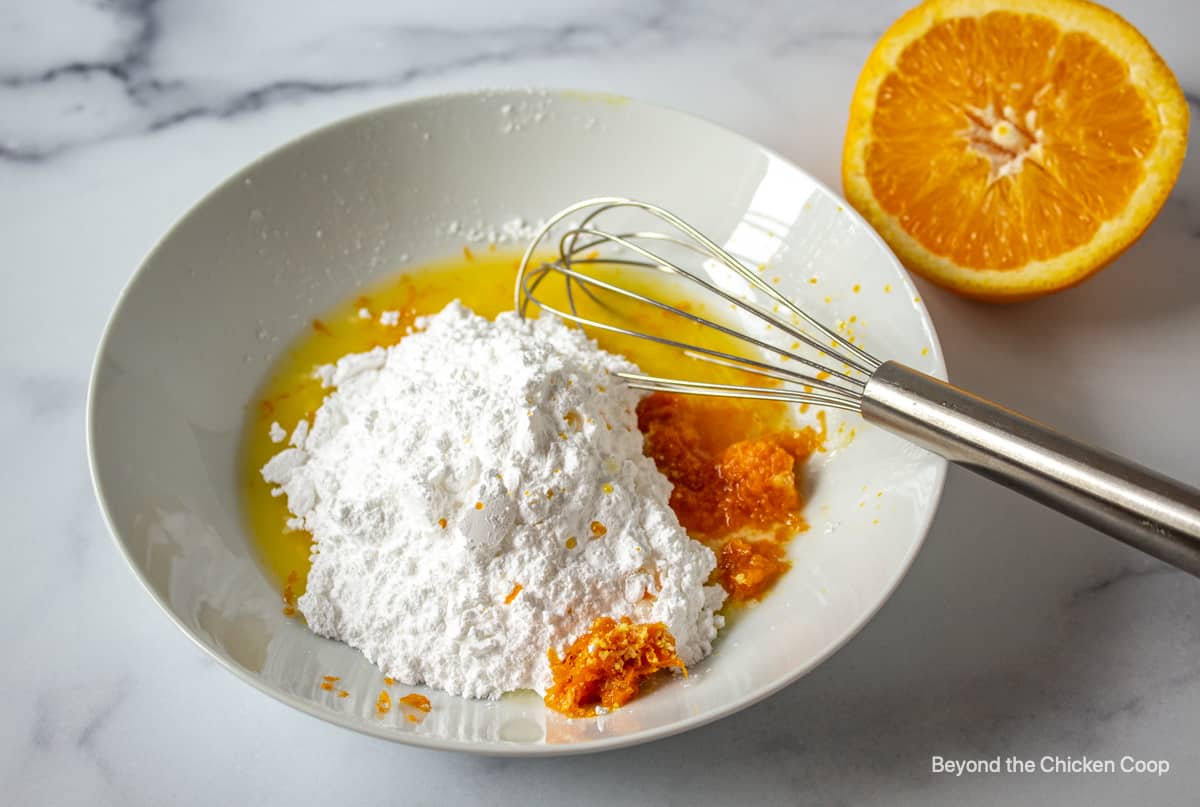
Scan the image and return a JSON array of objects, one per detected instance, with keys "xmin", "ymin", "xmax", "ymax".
[{"xmin": 546, "ymin": 616, "xmax": 688, "ymax": 717}]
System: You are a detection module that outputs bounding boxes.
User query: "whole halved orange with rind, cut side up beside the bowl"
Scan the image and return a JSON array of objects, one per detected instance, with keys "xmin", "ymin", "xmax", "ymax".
[{"xmin": 841, "ymin": 0, "xmax": 1188, "ymax": 301}]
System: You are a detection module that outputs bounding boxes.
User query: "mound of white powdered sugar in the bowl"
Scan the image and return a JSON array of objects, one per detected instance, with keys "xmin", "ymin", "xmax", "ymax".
[{"xmin": 263, "ymin": 303, "xmax": 725, "ymax": 698}]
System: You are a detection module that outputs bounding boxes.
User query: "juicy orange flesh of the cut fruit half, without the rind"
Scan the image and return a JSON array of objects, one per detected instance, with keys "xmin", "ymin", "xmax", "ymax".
[{"xmin": 865, "ymin": 12, "xmax": 1159, "ymax": 269}]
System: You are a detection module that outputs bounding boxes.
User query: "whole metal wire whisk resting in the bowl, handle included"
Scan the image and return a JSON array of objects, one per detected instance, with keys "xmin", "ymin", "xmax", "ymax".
[{"xmin": 515, "ymin": 197, "xmax": 1200, "ymax": 576}]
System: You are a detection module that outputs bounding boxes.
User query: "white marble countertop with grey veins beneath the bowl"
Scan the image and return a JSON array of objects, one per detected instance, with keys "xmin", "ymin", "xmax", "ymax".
[{"xmin": 0, "ymin": 0, "xmax": 1200, "ymax": 805}]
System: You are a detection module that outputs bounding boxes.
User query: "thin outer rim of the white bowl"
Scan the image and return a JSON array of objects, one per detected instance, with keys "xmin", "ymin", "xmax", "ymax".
[{"xmin": 84, "ymin": 86, "xmax": 948, "ymax": 758}]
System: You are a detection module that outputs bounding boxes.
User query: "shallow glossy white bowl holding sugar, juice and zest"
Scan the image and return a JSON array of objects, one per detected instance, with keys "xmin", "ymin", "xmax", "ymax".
[{"xmin": 88, "ymin": 91, "xmax": 946, "ymax": 754}]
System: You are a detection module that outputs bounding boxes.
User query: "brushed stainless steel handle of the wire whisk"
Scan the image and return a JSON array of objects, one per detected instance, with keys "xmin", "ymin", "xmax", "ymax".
[{"xmin": 863, "ymin": 361, "xmax": 1200, "ymax": 576}]
